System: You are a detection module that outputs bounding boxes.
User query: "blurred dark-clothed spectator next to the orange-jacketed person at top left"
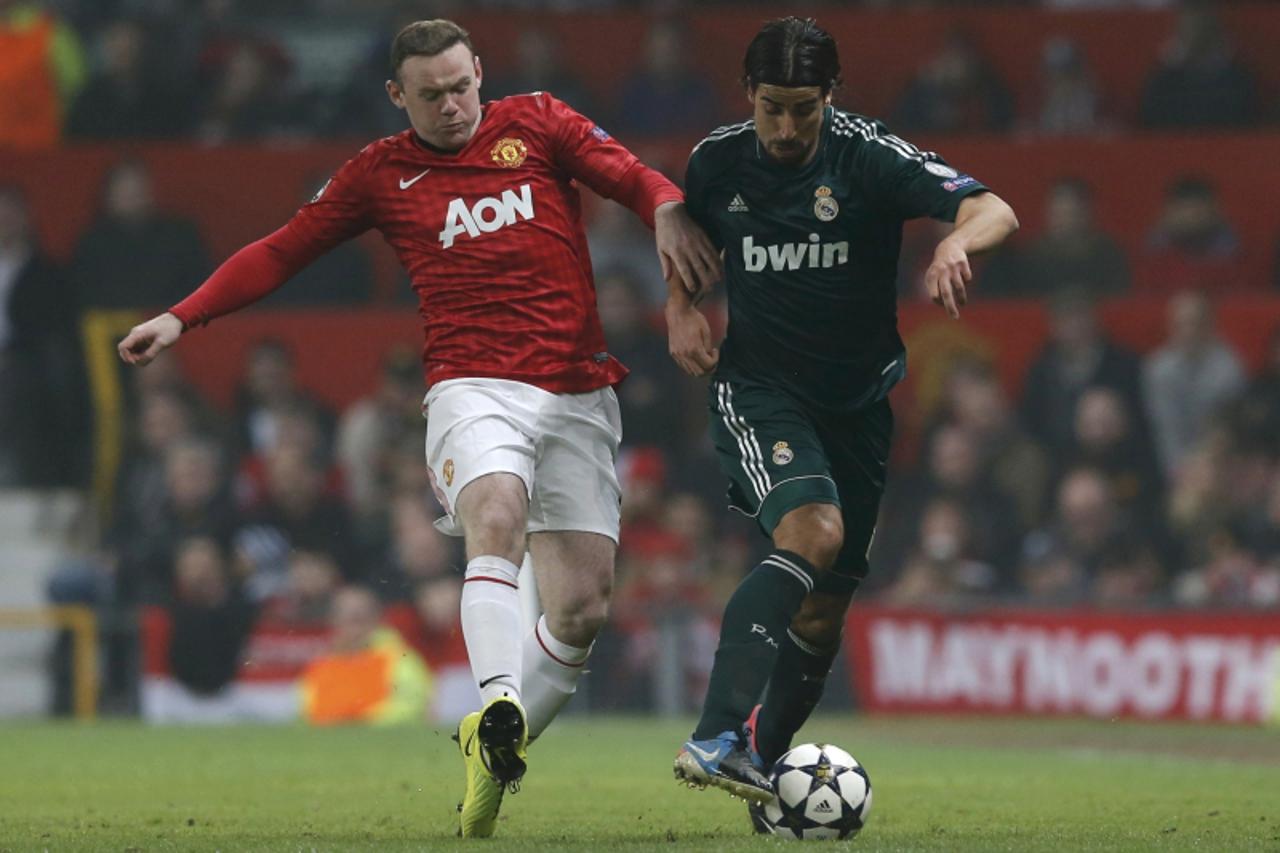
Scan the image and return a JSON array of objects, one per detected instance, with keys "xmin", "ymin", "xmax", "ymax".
[{"xmin": 67, "ymin": 19, "xmax": 188, "ymax": 140}]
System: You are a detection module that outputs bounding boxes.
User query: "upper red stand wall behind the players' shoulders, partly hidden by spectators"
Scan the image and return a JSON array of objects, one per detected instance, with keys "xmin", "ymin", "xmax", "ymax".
[{"xmin": 0, "ymin": 132, "xmax": 1280, "ymax": 301}]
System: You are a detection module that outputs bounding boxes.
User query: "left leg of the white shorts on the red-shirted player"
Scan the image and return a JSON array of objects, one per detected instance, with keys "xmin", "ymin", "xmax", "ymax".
[{"xmin": 422, "ymin": 379, "xmax": 545, "ymax": 535}]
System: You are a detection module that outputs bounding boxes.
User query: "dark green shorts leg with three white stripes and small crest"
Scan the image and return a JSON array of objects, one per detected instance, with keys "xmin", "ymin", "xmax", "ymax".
[{"xmin": 710, "ymin": 379, "xmax": 840, "ymax": 535}]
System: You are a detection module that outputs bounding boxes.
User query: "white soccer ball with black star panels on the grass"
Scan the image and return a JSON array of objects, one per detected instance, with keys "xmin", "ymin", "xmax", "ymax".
[{"xmin": 751, "ymin": 743, "xmax": 872, "ymax": 841}]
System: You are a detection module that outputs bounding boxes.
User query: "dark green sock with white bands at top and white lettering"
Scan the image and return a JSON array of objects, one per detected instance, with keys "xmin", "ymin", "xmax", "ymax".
[{"xmin": 694, "ymin": 551, "xmax": 818, "ymax": 740}]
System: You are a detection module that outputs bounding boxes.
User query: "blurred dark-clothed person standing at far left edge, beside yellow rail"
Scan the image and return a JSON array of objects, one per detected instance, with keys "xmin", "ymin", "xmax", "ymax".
[{"xmin": 0, "ymin": 184, "xmax": 91, "ymax": 488}]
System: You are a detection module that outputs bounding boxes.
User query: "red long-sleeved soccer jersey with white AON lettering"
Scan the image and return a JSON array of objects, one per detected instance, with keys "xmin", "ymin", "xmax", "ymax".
[{"xmin": 172, "ymin": 92, "xmax": 682, "ymax": 393}]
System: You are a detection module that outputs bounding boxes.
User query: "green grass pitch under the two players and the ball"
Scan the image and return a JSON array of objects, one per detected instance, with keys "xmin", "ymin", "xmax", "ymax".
[{"xmin": 0, "ymin": 716, "xmax": 1280, "ymax": 852}]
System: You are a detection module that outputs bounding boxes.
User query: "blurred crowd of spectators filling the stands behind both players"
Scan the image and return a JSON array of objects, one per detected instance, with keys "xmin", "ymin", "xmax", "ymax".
[{"xmin": 0, "ymin": 0, "xmax": 1280, "ymax": 722}]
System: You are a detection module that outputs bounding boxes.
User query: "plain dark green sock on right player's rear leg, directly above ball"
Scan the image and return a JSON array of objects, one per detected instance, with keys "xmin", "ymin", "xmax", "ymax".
[{"xmin": 755, "ymin": 629, "xmax": 840, "ymax": 767}]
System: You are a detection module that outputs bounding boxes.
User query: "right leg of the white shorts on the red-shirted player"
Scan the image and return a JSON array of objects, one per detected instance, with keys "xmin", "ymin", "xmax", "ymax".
[{"xmin": 529, "ymin": 388, "xmax": 622, "ymax": 543}]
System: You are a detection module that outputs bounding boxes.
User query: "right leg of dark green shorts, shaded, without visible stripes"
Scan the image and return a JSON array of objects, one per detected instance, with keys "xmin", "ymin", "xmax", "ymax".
[{"xmin": 818, "ymin": 400, "xmax": 893, "ymax": 592}]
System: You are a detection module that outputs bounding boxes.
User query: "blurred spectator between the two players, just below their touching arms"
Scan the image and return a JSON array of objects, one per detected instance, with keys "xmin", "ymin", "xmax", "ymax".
[{"xmin": 595, "ymin": 273, "xmax": 701, "ymax": 452}]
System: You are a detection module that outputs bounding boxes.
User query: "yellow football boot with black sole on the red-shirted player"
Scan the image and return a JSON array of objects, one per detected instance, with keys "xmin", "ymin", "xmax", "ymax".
[{"xmin": 453, "ymin": 697, "xmax": 529, "ymax": 838}]
